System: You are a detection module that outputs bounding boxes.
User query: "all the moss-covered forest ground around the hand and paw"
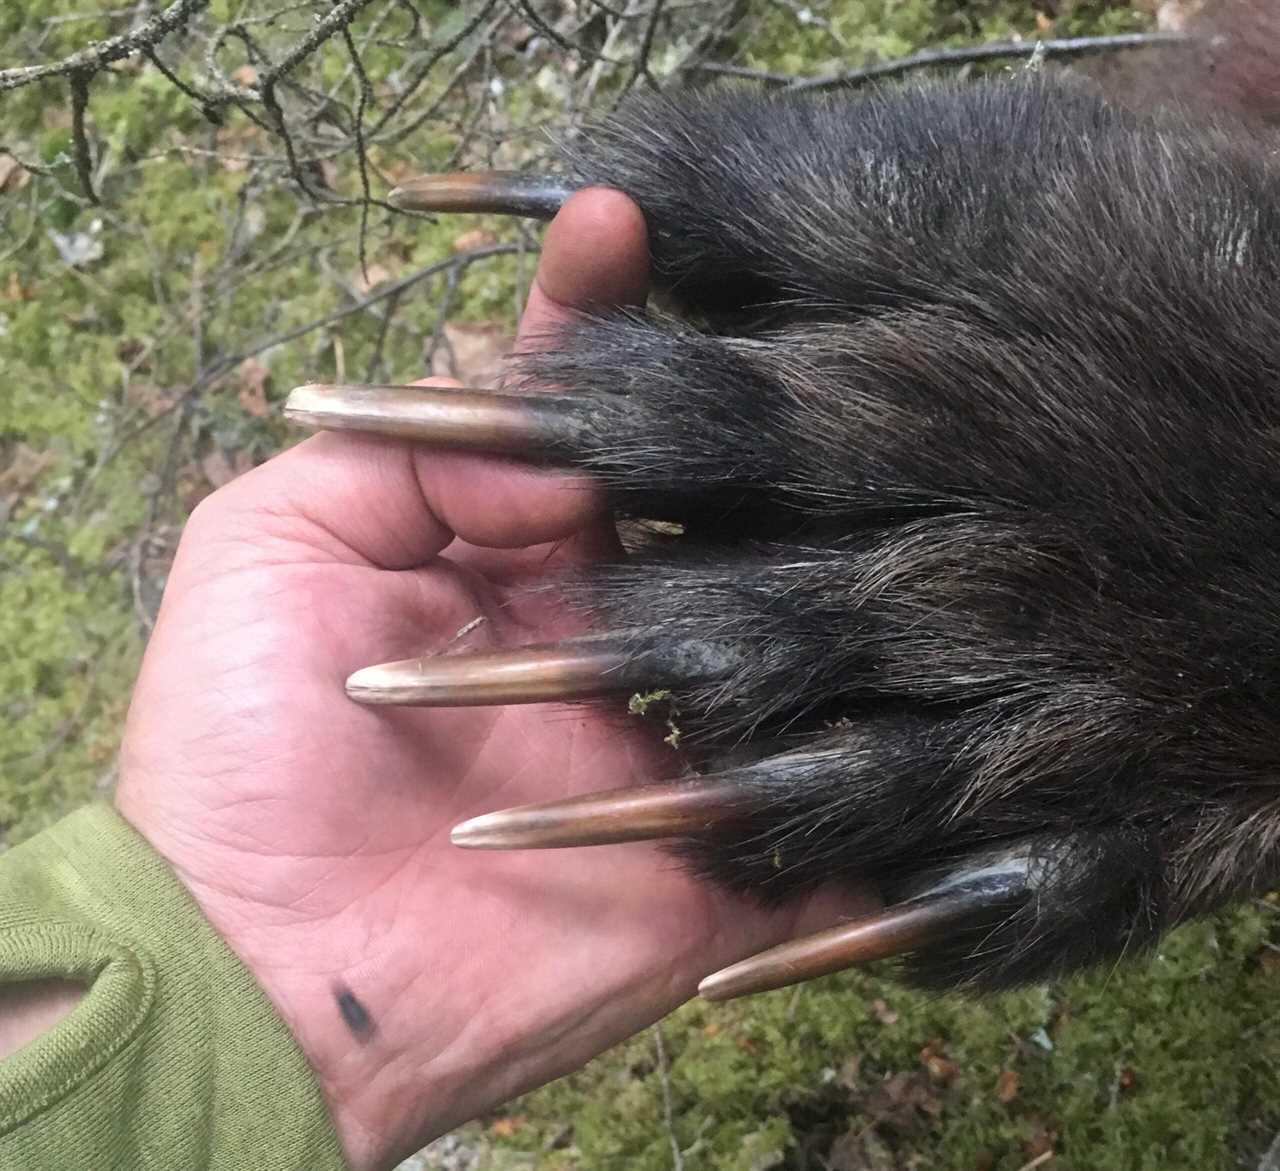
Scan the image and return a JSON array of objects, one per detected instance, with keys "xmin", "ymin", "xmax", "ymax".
[{"xmin": 0, "ymin": 0, "xmax": 1280, "ymax": 1171}]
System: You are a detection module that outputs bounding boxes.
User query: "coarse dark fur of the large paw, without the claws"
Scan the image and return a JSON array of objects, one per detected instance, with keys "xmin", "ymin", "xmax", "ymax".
[{"xmin": 506, "ymin": 15, "xmax": 1280, "ymax": 988}]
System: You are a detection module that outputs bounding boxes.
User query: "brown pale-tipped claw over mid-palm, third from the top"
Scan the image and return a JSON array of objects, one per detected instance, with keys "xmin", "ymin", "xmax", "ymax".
[{"xmin": 347, "ymin": 636, "xmax": 737, "ymax": 708}]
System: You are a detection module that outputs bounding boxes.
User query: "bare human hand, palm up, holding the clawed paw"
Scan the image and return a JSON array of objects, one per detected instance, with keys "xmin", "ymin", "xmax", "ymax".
[{"xmin": 116, "ymin": 189, "xmax": 870, "ymax": 1171}]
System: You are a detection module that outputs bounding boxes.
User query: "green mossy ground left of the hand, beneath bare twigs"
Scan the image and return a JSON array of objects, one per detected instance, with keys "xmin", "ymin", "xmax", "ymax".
[{"xmin": 0, "ymin": 0, "xmax": 515, "ymax": 840}]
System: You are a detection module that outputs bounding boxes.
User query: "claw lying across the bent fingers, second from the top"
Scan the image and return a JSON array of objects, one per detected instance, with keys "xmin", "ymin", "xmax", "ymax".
[{"xmin": 284, "ymin": 383, "xmax": 582, "ymax": 458}]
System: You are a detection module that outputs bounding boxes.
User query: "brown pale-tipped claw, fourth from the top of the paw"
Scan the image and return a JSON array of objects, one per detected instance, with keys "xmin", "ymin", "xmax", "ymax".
[{"xmin": 452, "ymin": 781, "xmax": 751, "ymax": 850}]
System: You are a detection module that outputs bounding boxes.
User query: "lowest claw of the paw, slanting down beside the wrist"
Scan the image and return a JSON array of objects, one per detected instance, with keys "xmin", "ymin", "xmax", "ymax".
[{"xmin": 698, "ymin": 855, "xmax": 1029, "ymax": 1001}]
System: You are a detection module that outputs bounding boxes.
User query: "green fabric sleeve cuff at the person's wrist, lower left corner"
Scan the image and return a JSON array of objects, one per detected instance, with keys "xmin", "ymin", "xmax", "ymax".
[{"xmin": 0, "ymin": 805, "xmax": 344, "ymax": 1171}]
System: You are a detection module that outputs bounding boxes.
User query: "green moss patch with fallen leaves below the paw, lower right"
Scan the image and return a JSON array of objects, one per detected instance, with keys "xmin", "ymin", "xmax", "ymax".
[{"xmin": 473, "ymin": 911, "xmax": 1277, "ymax": 1171}]
